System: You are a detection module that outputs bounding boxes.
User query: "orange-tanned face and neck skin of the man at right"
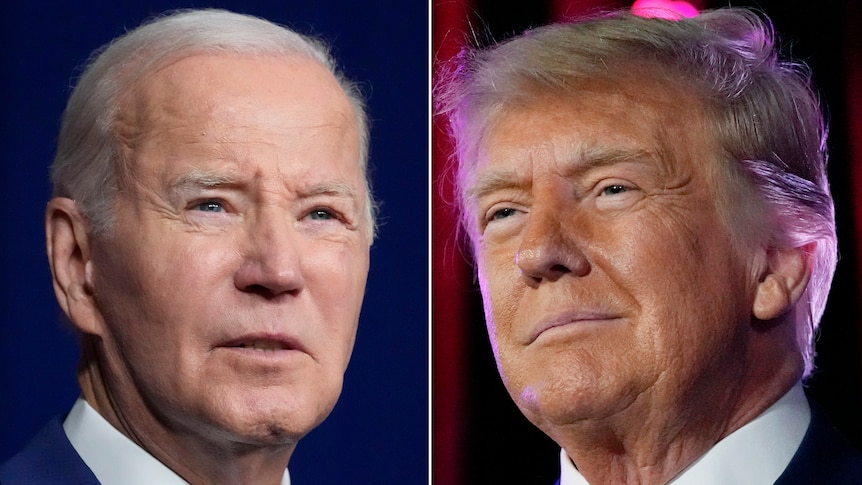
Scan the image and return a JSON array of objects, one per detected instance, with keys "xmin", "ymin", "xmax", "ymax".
[{"xmin": 465, "ymin": 72, "xmax": 800, "ymax": 483}]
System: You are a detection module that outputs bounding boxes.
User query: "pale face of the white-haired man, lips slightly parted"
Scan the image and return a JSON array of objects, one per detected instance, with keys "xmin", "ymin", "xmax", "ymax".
[{"xmin": 92, "ymin": 55, "xmax": 370, "ymax": 445}]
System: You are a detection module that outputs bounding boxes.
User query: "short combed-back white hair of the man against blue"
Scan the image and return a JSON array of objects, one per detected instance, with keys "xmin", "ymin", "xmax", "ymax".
[{"xmin": 51, "ymin": 9, "xmax": 376, "ymax": 240}]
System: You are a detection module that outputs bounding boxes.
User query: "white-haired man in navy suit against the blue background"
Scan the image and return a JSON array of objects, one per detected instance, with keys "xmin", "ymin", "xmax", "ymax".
[{"xmin": 0, "ymin": 10, "xmax": 374, "ymax": 484}]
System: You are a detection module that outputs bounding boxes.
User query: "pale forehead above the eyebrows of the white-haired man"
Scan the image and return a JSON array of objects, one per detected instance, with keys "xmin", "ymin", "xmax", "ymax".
[{"xmin": 114, "ymin": 55, "xmax": 360, "ymax": 170}]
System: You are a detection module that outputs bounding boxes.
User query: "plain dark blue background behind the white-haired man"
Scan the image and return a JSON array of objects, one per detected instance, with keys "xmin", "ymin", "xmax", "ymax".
[{"xmin": 0, "ymin": 0, "xmax": 428, "ymax": 485}]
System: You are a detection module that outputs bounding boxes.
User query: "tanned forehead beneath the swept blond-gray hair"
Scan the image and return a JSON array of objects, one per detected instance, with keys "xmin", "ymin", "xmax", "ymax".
[{"xmin": 458, "ymin": 72, "xmax": 740, "ymax": 238}]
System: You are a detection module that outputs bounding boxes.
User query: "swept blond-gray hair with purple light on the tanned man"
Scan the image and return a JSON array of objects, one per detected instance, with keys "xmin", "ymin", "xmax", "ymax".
[{"xmin": 435, "ymin": 8, "xmax": 837, "ymax": 376}]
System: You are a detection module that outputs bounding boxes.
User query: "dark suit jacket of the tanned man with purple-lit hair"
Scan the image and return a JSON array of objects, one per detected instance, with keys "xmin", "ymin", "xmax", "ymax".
[{"xmin": 556, "ymin": 400, "xmax": 862, "ymax": 485}]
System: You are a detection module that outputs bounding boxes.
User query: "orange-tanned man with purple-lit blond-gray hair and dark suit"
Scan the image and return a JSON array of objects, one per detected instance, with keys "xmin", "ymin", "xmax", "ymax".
[{"xmin": 437, "ymin": 9, "xmax": 862, "ymax": 485}]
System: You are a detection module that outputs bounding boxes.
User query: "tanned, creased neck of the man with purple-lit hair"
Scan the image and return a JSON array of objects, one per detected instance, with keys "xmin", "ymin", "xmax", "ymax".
[{"xmin": 546, "ymin": 354, "xmax": 801, "ymax": 484}]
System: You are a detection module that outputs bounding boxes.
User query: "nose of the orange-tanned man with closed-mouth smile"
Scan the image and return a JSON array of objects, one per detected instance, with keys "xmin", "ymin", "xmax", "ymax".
[{"xmin": 515, "ymin": 207, "xmax": 591, "ymax": 286}]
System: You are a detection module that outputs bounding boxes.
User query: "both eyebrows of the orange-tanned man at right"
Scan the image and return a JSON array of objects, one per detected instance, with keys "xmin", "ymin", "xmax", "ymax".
[{"xmin": 465, "ymin": 148, "xmax": 654, "ymax": 200}]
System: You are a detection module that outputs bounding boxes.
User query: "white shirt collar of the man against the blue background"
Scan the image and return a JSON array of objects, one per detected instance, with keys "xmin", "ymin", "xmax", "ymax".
[{"xmin": 63, "ymin": 399, "xmax": 290, "ymax": 485}]
